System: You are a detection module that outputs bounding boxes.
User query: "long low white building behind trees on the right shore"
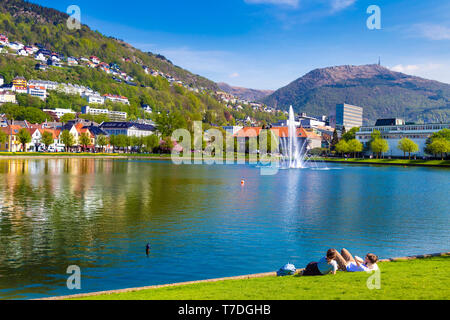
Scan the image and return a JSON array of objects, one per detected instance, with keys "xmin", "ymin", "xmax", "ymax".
[{"xmin": 356, "ymin": 119, "xmax": 450, "ymax": 157}]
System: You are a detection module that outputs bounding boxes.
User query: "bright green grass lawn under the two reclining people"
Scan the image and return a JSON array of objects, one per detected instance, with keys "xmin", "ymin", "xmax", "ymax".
[{"xmin": 73, "ymin": 255, "xmax": 450, "ymax": 300}]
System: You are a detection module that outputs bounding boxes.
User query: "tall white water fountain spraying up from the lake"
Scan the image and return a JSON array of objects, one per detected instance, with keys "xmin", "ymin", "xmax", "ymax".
[{"xmin": 280, "ymin": 106, "xmax": 308, "ymax": 169}]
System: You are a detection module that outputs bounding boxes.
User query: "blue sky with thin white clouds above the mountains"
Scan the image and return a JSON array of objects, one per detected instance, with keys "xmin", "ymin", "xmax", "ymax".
[{"xmin": 32, "ymin": 0, "xmax": 450, "ymax": 89}]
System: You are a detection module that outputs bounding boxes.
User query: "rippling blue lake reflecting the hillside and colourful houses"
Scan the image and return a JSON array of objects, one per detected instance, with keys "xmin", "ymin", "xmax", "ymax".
[{"xmin": 0, "ymin": 159, "xmax": 450, "ymax": 299}]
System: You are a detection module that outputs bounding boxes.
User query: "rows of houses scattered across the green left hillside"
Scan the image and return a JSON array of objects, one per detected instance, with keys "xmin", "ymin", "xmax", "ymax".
[{"xmin": 0, "ymin": 34, "xmax": 287, "ymax": 125}]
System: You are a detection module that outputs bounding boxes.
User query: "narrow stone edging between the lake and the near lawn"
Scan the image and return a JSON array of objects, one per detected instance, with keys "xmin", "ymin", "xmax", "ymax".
[{"xmin": 38, "ymin": 251, "xmax": 450, "ymax": 300}]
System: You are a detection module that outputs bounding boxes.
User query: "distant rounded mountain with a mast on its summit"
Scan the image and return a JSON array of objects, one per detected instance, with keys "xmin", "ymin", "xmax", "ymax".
[{"xmin": 262, "ymin": 65, "xmax": 450, "ymax": 124}]
